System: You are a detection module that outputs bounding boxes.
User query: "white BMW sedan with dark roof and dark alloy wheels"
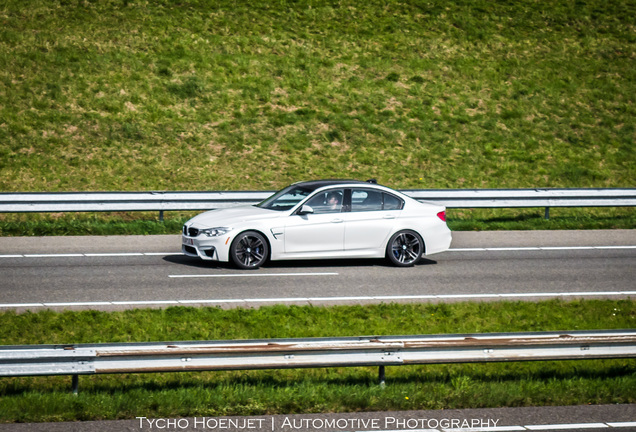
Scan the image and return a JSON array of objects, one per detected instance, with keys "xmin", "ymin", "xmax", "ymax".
[{"xmin": 182, "ymin": 180, "xmax": 451, "ymax": 269}]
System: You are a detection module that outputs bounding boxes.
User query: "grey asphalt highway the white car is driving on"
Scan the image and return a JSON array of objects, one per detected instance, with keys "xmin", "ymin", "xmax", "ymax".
[{"xmin": 0, "ymin": 230, "xmax": 636, "ymax": 310}]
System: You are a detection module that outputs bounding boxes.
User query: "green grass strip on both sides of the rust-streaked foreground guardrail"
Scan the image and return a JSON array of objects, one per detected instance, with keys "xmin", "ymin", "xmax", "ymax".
[{"xmin": 0, "ymin": 300, "xmax": 636, "ymax": 422}]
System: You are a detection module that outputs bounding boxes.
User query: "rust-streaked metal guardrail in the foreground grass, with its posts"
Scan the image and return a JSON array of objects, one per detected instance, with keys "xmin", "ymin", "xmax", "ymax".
[{"xmin": 0, "ymin": 330, "xmax": 636, "ymax": 392}]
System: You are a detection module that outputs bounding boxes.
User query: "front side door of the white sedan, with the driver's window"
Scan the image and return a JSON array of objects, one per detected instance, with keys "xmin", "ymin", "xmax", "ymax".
[{"xmin": 284, "ymin": 189, "xmax": 344, "ymax": 256}]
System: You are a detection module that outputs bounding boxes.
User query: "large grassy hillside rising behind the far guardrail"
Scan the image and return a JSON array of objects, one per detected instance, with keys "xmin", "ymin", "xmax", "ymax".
[{"xmin": 0, "ymin": 0, "xmax": 636, "ymax": 191}]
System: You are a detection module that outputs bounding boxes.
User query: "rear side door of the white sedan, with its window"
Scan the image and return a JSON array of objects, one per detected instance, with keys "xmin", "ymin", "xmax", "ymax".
[{"xmin": 345, "ymin": 188, "xmax": 403, "ymax": 253}]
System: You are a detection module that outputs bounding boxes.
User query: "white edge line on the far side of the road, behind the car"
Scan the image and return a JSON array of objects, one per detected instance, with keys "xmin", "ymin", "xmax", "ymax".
[{"xmin": 0, "ymin": 246, "xmax": 636, "ymax": 258}]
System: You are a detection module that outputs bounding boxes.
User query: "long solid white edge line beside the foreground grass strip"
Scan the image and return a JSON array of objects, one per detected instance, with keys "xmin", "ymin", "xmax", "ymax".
[{"xmin": 0, "ymin": 291, "xmax": 636, "ymax": 309}]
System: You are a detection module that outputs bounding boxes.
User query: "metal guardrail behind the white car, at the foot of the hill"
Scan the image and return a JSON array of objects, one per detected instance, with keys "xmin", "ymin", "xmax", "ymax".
[{"xmin": 0, "ymin": 189, "xmax": 636, "ymax": 213}]
